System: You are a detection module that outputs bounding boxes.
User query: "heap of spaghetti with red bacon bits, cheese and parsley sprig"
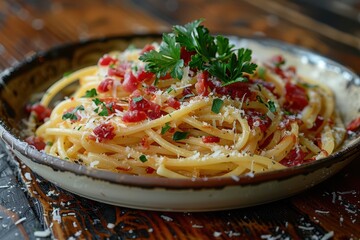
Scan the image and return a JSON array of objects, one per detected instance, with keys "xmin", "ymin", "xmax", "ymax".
[{"xmin": 27, "ymin": 20, "xmax": 345, "ymax": 178}]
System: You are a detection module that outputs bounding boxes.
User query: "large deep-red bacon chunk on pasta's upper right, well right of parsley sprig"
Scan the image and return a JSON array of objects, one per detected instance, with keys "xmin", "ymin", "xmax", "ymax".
[{"xmin": 284, "ymin": 82, "xmax": 309, "ymax": 112}]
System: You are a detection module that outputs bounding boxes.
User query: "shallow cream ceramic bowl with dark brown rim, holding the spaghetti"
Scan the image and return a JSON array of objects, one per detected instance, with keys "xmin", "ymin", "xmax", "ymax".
[{"xmin": 0, "ymin": 35, "xmax": 360, "ymax": 211}]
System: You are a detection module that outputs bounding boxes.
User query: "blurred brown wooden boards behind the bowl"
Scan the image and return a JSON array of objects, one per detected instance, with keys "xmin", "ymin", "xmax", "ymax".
[{"xmin": 0, "ymin": 0, "xmax": 360, "ymax": 73}]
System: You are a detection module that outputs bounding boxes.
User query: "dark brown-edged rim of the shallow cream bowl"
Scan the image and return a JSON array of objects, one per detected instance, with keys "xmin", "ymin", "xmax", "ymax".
[{"xmin": 0, "ymin": 33, "xmax": 360, "ymax": 189}]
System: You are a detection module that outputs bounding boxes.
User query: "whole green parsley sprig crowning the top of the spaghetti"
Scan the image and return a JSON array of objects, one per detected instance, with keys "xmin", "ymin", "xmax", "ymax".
[{"xmin": 140, "ymin": 19, "xmax": 257, "ymax": 86}]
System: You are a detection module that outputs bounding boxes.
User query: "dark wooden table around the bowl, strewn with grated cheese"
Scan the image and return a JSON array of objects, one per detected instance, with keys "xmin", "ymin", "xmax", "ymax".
[{"xmin": 0, "ymin": 0, "xmax": 360, "ymax": 239}]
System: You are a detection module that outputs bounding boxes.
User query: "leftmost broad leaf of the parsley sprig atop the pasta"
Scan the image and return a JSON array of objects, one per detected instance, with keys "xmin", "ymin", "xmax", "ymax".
[{"xmin": 139, "ymin": 34, "xmax": 184, "ymax": 79}]
